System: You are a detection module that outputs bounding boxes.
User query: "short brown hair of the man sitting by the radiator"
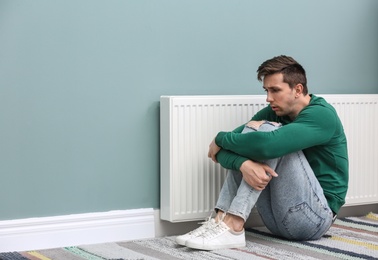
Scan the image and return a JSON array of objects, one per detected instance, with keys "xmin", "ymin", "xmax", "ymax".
[{"xmin": 257, "ymin": 55, "xmax": 308, "ymax": 95}]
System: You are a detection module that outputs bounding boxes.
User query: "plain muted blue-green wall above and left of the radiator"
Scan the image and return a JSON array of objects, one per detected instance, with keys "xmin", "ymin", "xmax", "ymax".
[{"xmin": 0, "ymin": 0, "xmax": 378, "ymax": 219}]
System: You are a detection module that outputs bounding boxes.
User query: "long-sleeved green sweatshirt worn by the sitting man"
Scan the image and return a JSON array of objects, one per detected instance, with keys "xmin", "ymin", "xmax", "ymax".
[{"xmin": 215, "ymin": 95, "xmax": 348, "ymax": 213}]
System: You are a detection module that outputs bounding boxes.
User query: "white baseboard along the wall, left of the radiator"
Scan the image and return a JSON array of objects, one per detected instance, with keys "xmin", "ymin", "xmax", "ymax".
[{"xmin": 0, "ymin": 209, "xmax": 155, "ymax": 252}]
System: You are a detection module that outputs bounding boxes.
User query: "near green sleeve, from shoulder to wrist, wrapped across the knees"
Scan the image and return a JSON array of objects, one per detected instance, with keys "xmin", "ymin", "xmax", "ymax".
[{"xmin": 215, "ymin": 106, "xmax": 337, "ymax": 161}]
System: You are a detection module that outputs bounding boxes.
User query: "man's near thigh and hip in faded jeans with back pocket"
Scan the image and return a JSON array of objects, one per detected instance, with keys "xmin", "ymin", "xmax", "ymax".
[{"xmin": 256, "ymin": 124, "xmax": 333, "ymax": 240}]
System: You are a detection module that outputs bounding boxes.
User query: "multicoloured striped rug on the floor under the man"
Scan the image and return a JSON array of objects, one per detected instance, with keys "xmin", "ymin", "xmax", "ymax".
[{"xmin": 0, "ymin": 213, "xmax": 378, "ymax": 260}]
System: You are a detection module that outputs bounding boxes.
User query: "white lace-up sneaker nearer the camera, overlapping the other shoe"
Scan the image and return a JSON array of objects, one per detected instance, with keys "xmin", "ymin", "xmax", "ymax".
[{"xmin": 185, "ymin": 221, "xmax": 246, "ymax": 250}]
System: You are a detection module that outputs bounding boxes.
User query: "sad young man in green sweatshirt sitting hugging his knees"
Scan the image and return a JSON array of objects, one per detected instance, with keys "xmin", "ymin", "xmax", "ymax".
[{"xmin": 176, "ymin": 56, "xmax": 348, "ymax": 250}]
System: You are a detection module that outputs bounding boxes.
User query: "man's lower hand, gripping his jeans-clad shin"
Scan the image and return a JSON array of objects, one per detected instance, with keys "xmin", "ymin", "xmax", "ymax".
[{"xmin": 240, "ymin": 160, "xmax": 278, "ymax": 190}]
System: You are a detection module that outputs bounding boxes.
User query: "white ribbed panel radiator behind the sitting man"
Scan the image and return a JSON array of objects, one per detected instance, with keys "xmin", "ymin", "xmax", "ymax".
[{"xmin": 160, "ymin": 95, "xmax": 378, "ymax": 222}]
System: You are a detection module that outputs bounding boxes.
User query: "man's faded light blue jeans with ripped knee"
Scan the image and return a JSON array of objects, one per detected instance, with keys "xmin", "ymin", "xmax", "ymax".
[{"xmin": 215, "ymin": 122, "xmax": 333, "ymax": 240}]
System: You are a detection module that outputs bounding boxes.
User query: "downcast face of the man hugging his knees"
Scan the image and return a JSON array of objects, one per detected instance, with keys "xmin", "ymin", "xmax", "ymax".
[{"xmin": 263, "ymin": 73, "xmax": 297, "ymax": 119}]
